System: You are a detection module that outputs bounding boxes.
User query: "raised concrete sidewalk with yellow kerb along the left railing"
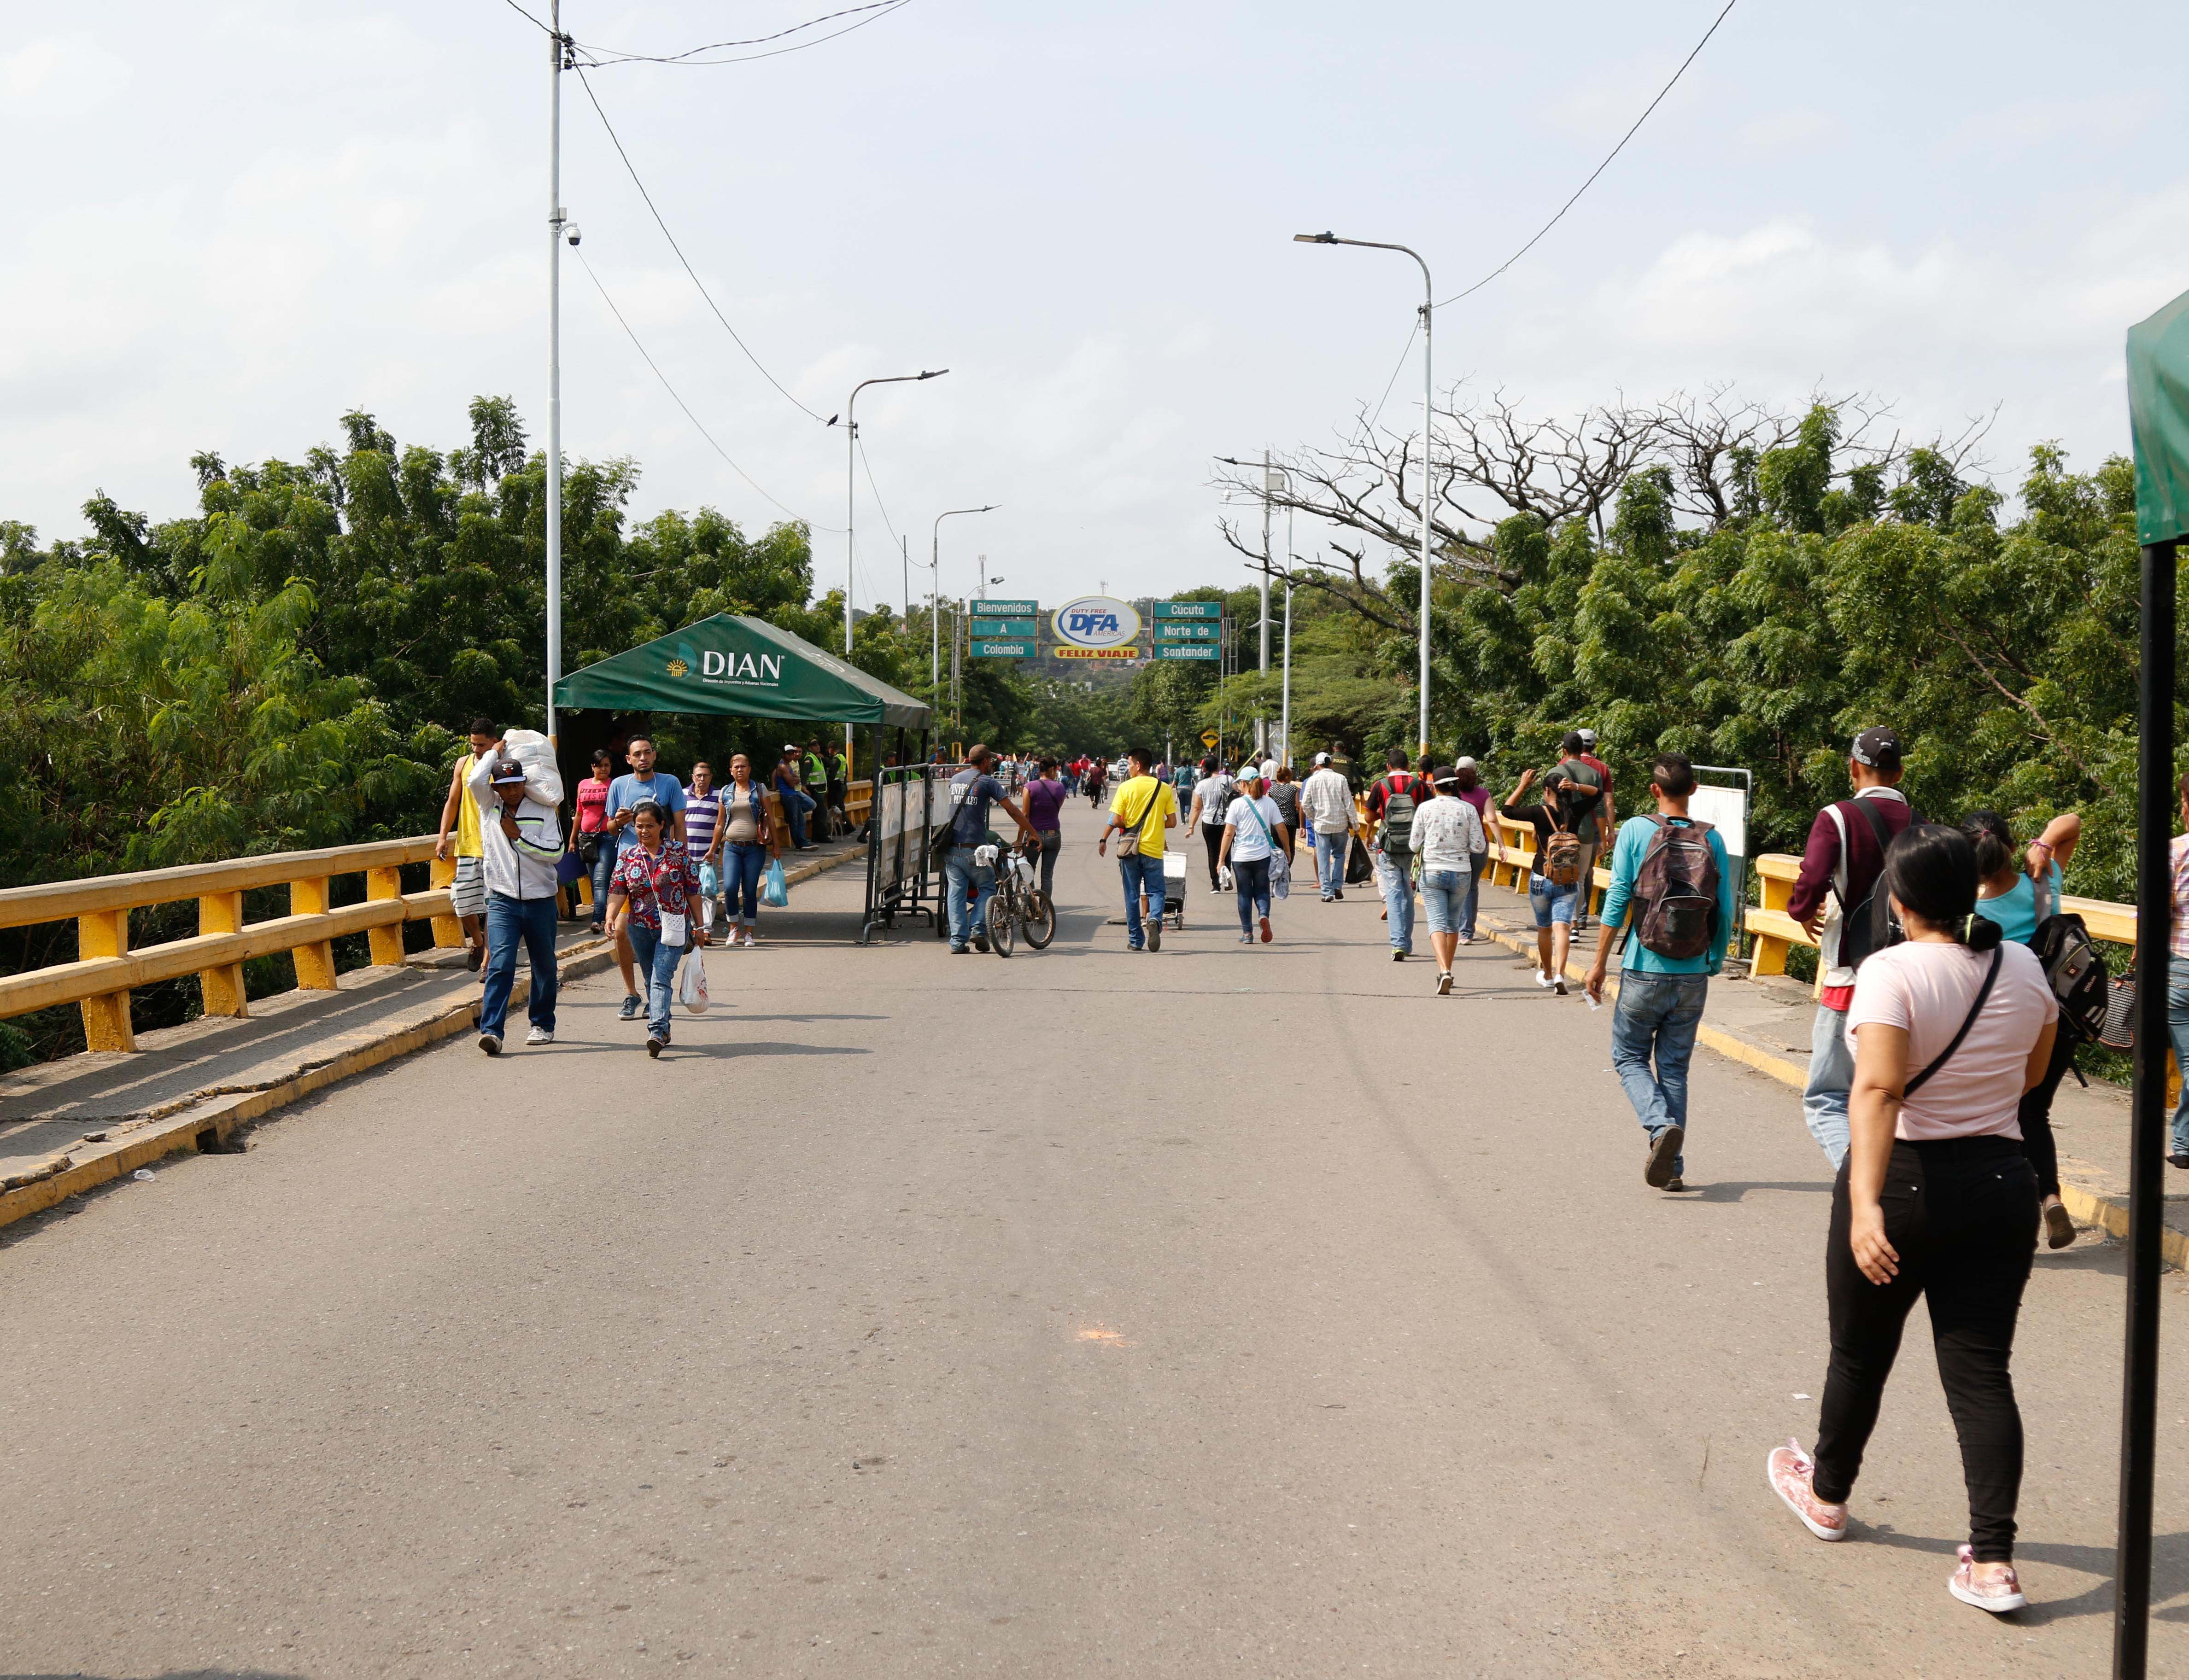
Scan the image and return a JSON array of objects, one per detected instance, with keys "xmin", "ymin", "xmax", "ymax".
[{"xmin": 0, "ymin": 840, "xmax": 867, "ymax": 1225}]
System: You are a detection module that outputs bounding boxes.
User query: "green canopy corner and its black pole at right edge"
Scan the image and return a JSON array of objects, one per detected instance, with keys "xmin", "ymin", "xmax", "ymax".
[{"xmin": 2113, "ymin": 293, "xmax": 2189, "ymax": 1676}]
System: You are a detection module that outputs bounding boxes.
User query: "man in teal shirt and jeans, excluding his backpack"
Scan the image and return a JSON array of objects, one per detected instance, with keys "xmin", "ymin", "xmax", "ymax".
[{"xmin": 1587, "ymin": 752, "xmax": 1740, "ymax": 1190}]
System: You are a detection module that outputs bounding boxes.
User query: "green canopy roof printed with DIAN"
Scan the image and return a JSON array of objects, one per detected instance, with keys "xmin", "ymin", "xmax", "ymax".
[{"xmin": 554, "ymin": 612, "xmax": 932, "ymax": 729}]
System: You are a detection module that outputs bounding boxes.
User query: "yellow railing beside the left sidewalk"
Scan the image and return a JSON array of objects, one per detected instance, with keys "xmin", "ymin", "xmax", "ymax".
[{"xmin": 0, "ymin": 836, "xmax": 464, "ymax": 1050}]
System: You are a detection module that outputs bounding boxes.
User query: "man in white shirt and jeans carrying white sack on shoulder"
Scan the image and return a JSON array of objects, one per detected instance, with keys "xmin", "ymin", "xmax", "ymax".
[{"xmin": 468, "ymin": 757, "xmax": 562, "ymax": 1056}]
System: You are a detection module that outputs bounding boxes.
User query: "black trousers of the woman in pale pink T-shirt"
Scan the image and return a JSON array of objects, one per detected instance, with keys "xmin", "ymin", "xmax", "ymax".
[{"xmin": 1814, "ymin": 1138, "xmax": 2038, "ymax": 1564}]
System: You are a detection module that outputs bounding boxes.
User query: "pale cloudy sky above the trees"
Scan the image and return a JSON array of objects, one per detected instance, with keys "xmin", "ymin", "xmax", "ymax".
[{"xmin": 0, "ymin": 0, "xmax": 2189, "ymax": 606}]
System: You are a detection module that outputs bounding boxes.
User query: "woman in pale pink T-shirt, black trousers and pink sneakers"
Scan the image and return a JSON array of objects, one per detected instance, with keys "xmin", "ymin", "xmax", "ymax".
[{"xmin": 1767, "ymin": 822, "xmax": 2058, "ymax": 1612}]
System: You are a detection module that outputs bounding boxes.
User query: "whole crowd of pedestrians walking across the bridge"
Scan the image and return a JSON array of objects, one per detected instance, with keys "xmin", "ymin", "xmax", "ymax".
[{"xmin": 438, "ymin": 720, "xmax": 2145, "ymax": 1612}]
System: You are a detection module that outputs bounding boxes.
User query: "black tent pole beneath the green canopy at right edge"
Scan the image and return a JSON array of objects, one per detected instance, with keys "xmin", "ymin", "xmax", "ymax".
[{"xmin": 2113, "ymin": 542, "xmax": 2178, "ymax": 1680}]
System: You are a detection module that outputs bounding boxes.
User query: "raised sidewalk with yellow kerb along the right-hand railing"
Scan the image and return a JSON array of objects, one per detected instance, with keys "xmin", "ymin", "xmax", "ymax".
[{"xmin": 1453, "ymin": 886, "xmax": 2189, "ymax": 1271}]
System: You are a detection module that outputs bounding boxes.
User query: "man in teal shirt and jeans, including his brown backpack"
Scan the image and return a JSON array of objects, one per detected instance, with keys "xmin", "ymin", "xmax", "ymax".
[{"xmin": 1587, "ymin": 752, "xmax": 1740, "ymax": 1190}]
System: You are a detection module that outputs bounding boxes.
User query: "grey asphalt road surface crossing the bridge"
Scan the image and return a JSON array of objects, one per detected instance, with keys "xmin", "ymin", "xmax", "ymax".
[{"xmin": 0, "ymin": 805, "xmax": 2189, "ymax": 1680}]
